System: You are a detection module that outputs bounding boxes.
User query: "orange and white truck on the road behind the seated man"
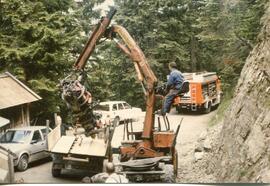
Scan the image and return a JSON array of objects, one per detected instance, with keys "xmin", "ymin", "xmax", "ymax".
[{"xmin": 173, "ymin": 72, "xmax": 222, "ymax": 113}]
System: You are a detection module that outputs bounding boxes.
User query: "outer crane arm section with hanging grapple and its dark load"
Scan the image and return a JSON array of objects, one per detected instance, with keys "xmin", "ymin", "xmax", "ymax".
[{"xmin": 59, "ymin": 9, "xmax": 116, "ymax": 136}]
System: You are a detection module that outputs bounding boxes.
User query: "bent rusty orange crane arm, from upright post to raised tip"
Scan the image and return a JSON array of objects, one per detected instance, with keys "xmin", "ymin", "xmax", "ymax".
[{"xmin": 74, "ymin": 9, "xmax": 157, "ymax": 139}]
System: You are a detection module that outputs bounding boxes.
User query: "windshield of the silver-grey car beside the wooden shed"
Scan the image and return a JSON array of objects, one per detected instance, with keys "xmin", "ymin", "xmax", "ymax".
[{"xmin": 0, "ymin": 130, "xmax": 31, "ymax": 143}]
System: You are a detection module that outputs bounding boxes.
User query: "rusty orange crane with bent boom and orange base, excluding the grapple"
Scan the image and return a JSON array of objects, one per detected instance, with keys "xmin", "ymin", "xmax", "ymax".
[{"xmin": 69, "ymin": 9, "xmax": 176, "ymax": 169}]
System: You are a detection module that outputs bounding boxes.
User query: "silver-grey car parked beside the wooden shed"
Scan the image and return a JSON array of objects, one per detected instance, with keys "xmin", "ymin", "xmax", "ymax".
[{"xmin": 0, "ymin": 126, "xmax": 51, "ymax": 171}]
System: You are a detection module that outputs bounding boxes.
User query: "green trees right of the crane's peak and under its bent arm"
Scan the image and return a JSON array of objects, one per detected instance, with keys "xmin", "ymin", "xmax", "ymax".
[{"xmin": 94, "ymin": 0, "xmax": 264, "ymax": 109}]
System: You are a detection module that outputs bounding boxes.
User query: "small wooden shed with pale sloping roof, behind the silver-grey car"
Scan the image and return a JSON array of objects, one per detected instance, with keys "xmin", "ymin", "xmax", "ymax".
[{"xmin": 0, "ymin": 72, "xmax": 41, "ymax": 132}]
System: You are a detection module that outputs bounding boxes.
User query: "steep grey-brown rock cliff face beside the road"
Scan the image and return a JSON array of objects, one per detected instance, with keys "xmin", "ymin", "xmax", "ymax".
[{"xmin": 209, "ymin": 3, "xmax": 270, "ymax": 183}]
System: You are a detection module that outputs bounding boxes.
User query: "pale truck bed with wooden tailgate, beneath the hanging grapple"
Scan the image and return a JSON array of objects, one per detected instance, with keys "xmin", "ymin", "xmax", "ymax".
[{"xmin": 48, "ymin": 125, "xmax": 114, "ymax": 177}]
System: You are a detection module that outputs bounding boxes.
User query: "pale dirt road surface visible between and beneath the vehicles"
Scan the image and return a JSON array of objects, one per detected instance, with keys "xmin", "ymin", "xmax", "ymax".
[{"xmin": 15, "ymin": 111, "xmax": 216, "ymax": 183}]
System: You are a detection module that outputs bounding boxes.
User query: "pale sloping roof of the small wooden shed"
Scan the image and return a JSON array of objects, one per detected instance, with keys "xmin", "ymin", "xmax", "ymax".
[{"xmin": 0, "ymin": 72, "xmax": 41, "ymax": 109}]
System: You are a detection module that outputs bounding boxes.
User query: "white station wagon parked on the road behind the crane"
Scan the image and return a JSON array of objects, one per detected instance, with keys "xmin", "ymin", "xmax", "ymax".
[{"xmin": 95, "ymin": 101, "xmax": 142, "ymax": 123}]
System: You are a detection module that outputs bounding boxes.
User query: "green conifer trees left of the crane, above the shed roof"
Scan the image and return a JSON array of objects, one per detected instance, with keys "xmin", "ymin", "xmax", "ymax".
[{"xmin": 0, "ymin": 0, "xmax": 101, "ymax": 123}]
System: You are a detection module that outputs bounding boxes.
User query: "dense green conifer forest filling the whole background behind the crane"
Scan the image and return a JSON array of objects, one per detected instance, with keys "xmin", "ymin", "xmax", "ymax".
[{"xmin": 0, "ymin": 0, "xmax": 266, "ymax": 124}]
